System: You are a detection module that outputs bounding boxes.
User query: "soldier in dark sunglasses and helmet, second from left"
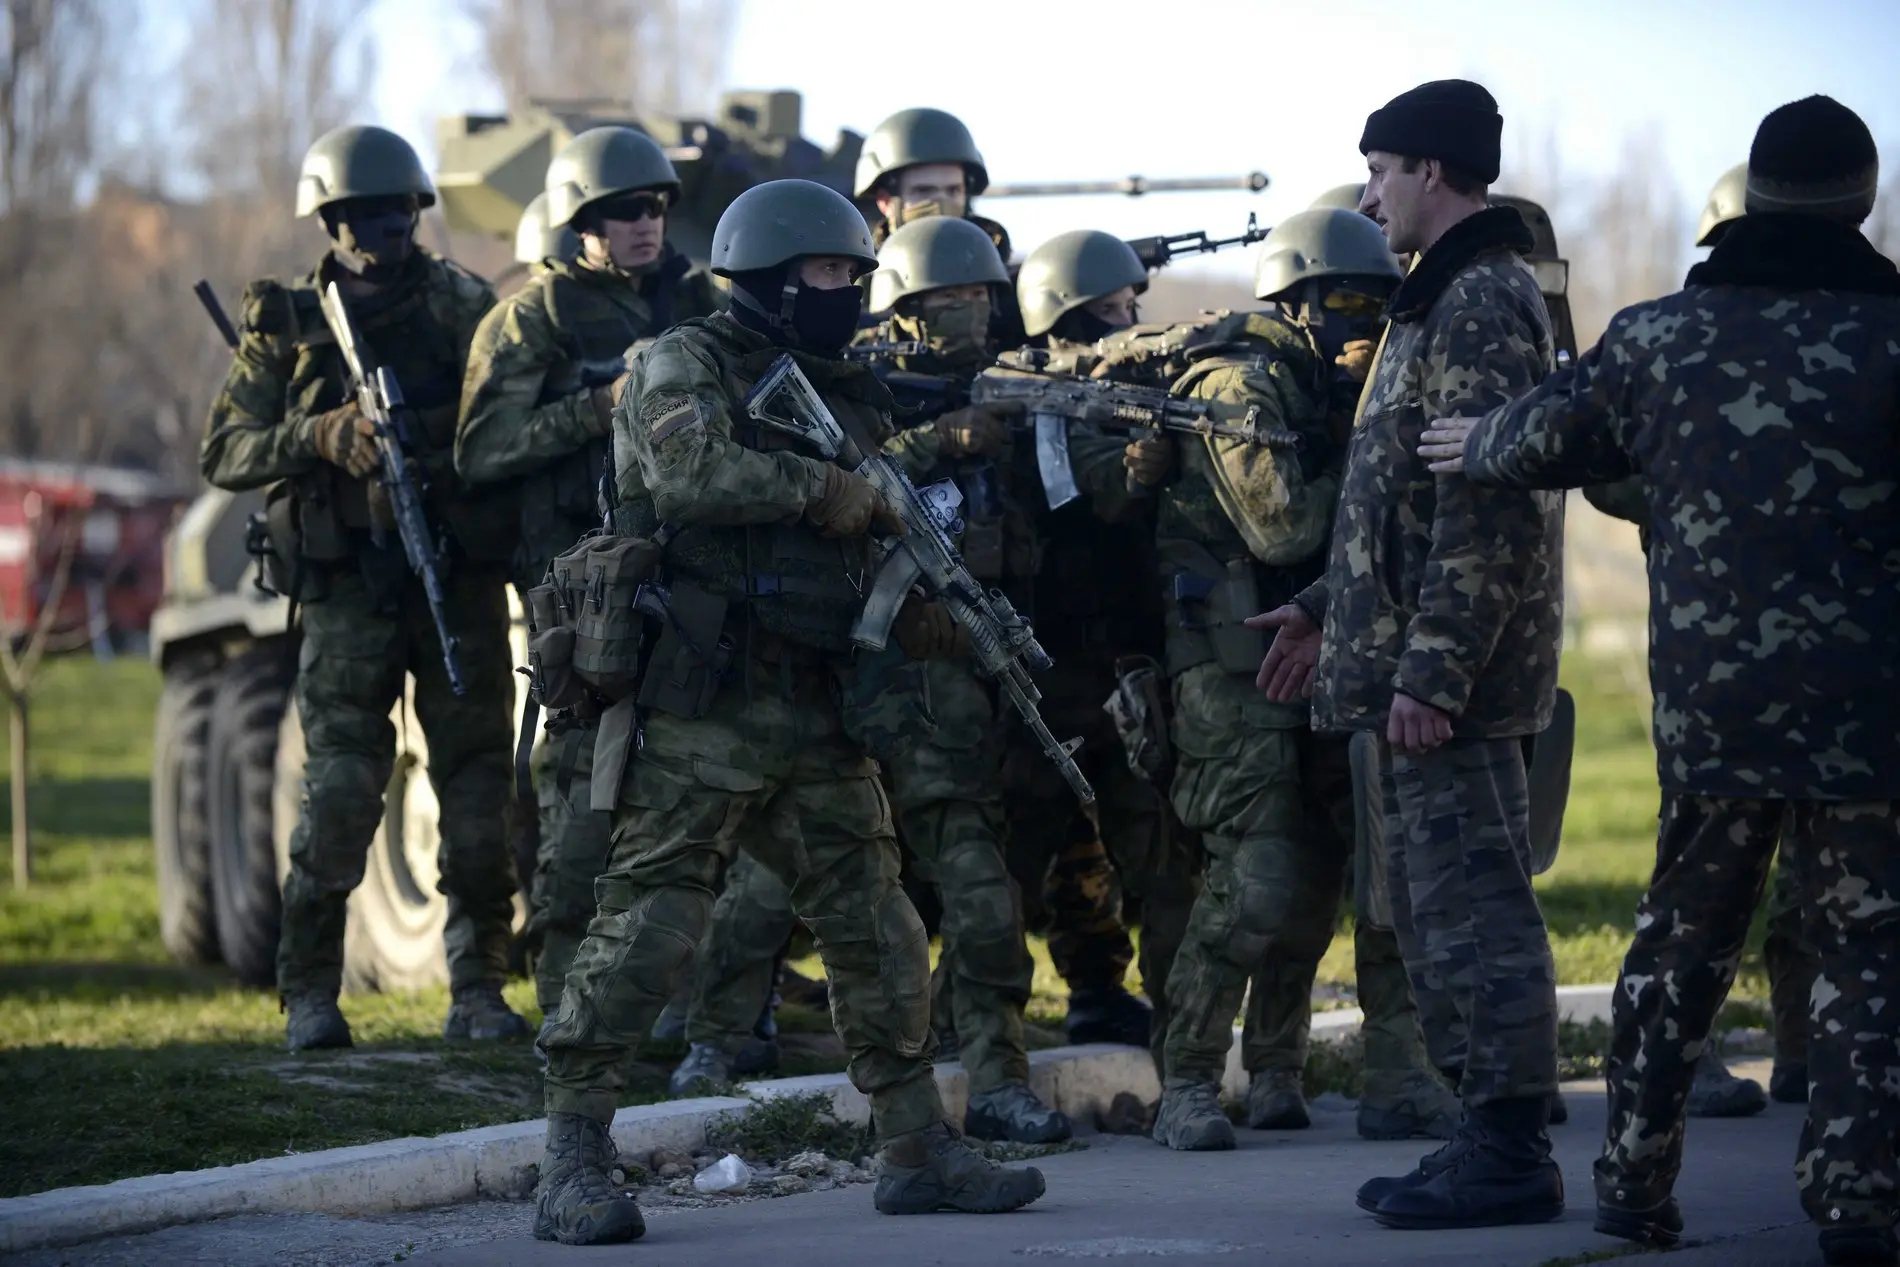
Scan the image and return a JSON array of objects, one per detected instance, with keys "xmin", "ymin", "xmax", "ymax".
[{"xmin": 456, "ymin": 127, "xmax": 718, "ymax": 1014}]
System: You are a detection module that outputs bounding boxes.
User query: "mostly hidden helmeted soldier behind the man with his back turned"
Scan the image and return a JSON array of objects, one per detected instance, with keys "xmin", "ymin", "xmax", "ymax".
[{"xmin": 1583, "ymin": 163, "xmax": 1820, "ymax": 1117}]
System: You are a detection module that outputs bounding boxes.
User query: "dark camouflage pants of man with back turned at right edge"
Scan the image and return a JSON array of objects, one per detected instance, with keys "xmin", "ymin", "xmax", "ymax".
[{"xmin": 1596, "ymin": 792, "xmax": 1900, "ymax": 1227}]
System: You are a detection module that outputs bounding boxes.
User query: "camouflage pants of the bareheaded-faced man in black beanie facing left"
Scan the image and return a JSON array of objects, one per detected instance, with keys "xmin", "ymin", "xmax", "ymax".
[{"xmin": 1379, "ymin": 737, "xmax": 1556, "ymax": 1104}]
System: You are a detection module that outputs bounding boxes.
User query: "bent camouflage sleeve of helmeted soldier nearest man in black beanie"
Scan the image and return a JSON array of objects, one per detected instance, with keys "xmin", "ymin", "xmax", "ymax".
[{"xmin": 1180, "ymin": 361, "xmax": 1340, "ymax": 566}]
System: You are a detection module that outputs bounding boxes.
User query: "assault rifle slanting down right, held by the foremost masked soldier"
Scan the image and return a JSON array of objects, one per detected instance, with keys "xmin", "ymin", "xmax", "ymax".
[{"xmin": 745, "ymin": 353, "xmax": 1094, "ymax": 805}]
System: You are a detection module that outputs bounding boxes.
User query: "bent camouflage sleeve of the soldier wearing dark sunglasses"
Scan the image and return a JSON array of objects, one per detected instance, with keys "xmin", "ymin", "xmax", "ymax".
[{"xmin": 456, "ymin": 289, "xmax": 600, "ymax": 484}]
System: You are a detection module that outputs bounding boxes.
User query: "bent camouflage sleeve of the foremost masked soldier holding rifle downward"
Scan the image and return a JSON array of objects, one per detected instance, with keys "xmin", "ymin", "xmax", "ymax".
[{"xmin": 614, "ymin": 334, "xmax": 825, "ymax": 526}]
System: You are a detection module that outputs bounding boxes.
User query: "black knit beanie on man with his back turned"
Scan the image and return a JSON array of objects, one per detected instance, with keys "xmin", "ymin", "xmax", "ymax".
[{"xmin": 1744, "ymin": 95, "xmax": 1881, "ymax": 224}]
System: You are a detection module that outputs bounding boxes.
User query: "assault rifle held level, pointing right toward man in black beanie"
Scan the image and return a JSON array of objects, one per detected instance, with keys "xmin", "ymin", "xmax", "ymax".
[{"xmin": 969, "ymin": 361, "xmax": 1300, "ymax": 509}]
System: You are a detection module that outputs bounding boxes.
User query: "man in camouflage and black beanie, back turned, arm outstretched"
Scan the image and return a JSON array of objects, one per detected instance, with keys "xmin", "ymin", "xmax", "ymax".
[{"xmin": 1421, "ymin": 97, "xmax": 1900, "ymax": 1263}]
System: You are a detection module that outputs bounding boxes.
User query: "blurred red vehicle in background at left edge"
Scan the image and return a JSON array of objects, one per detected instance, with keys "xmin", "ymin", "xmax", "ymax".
[{"xmin": 0, "ymin": 458, "xmax": 188, "ymax": 648}]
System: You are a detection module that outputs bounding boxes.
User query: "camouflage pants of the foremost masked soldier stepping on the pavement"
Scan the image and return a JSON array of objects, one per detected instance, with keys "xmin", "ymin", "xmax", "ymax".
[{"xmin": 542, "ymin": 659, "xmax": 944, "ymax": 1138}]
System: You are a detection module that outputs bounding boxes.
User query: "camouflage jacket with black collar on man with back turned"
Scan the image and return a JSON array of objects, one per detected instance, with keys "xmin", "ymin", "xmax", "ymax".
[{"xmin": 1465, "ymin": 217, "xmax": 1900, "ymax": 802}]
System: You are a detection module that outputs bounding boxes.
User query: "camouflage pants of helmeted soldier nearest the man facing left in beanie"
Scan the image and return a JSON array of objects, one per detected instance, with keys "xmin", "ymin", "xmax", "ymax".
[{"xmin": 1165, "ymin": 665, "xmax": 1353, "ymax": 1085}]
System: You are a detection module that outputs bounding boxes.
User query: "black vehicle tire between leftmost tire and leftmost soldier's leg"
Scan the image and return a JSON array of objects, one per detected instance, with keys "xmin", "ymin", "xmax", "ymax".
[{"xmin": 209, "ymin": 638, "xmax": 291, "ymax": 986}]
